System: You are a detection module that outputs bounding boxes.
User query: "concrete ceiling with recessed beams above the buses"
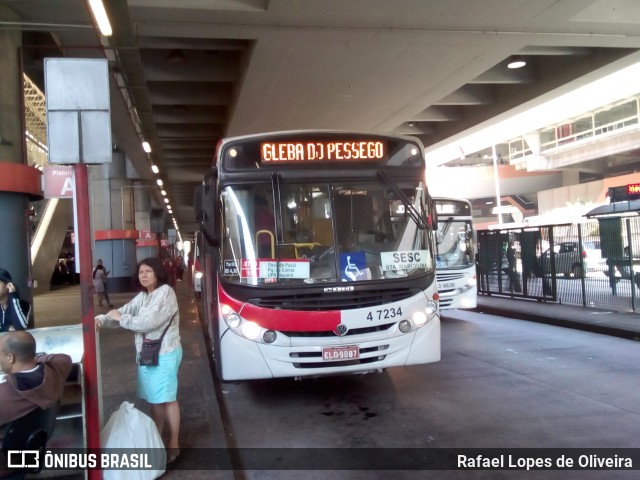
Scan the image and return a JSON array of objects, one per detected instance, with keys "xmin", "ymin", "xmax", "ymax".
[{"xmin": 0, "ymin": 0, "xmax": 640, "ymax": 233}]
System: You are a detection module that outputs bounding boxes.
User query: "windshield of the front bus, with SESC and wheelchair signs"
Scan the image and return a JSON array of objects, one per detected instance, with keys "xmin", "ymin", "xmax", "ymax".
[{"xmin": 220, "ymin": 180, "xmax": 434, "ymax": 287}]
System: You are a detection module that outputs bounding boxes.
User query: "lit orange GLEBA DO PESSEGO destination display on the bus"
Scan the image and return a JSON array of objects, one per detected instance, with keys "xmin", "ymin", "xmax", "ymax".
[{"xmin": 260, "ymin": 140, "xmax": 387, "ymax": 163}]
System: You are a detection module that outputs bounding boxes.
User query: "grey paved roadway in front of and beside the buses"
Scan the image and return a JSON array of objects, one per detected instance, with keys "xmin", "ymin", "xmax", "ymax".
[{"xmin": 215, "ymin": 311, "xmax": 640, "ymax": 479}]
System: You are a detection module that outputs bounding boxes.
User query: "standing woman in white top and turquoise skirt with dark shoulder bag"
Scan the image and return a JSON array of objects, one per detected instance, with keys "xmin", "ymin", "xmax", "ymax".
[{"xmin": 96, "ymin": 257, "xmax": 182, "ymax": 462}]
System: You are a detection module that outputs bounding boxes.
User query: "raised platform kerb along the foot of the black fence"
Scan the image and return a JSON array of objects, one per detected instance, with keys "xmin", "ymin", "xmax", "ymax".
[{"xmin": 476, "ymin": 295, "xmax": 640, "ymax": 341}]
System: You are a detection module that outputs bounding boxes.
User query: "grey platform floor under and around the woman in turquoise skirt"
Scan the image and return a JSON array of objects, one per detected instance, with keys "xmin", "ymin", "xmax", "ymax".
[{"xmin": 33, "ymin": 280, "xmax": 234, "ymax": 480}]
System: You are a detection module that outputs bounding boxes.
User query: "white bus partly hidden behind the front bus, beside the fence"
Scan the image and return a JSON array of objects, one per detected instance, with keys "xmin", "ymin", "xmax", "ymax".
[{"xmin": 433, "ymin": 197, "xmax": 478, "ymax": 310}]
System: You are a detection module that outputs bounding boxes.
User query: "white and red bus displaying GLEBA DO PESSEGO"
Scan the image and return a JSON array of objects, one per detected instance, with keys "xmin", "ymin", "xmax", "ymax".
[{"xmin": 196, "ymin": 131, "xmax": 440, "ymax": 380}]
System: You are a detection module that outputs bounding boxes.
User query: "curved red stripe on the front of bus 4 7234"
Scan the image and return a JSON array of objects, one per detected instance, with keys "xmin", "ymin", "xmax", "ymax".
[{"xmin": 218, "ymin": 284, "xmax": 340, "ymax": 332}]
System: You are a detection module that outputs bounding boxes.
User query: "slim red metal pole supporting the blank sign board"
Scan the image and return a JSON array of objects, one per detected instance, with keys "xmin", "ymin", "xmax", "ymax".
[{"xmin": 74, "ymin": 163, "xmax": 102, "ymax": 480}]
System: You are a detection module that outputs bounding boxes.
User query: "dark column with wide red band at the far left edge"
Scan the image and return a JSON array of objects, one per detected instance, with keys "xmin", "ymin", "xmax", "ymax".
[{"xmin": 0, "ymin": 6, "xmax": 42, "ymax": 324}]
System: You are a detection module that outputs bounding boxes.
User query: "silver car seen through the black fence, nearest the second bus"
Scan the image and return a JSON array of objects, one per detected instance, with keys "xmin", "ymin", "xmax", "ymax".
[{"xmin": 542, "ymin": 240, "xmax": 606, "ymax": 278}]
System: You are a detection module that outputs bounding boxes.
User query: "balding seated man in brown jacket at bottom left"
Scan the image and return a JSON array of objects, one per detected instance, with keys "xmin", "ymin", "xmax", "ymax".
[{"xmin": 0, "ymin": 330, "xmax": 71, "ymax": 478}]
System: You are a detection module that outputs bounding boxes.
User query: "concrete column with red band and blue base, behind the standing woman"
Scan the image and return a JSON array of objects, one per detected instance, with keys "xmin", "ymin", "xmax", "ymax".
[{"xmin": 91, "ymin": 152, "xmax": 138, "ymax": 292}]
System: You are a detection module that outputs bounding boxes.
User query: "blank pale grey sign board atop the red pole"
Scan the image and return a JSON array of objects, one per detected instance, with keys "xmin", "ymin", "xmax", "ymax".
[{"xmin": 44, "ymin": 58, "xmax": 112, "ymax": 165}]
